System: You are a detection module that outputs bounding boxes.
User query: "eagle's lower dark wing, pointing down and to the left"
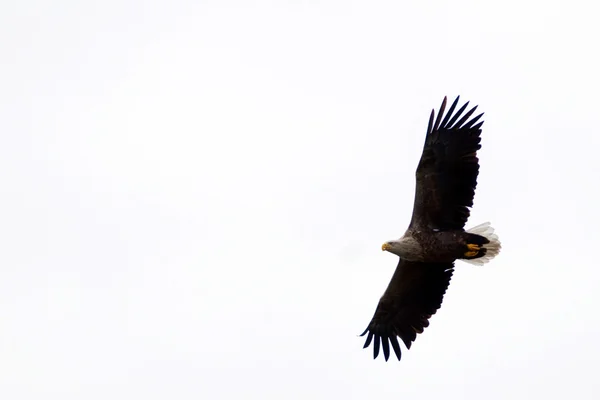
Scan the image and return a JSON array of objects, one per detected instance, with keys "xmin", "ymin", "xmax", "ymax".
[{"xmin": 361, "ymin": 259, "xmax": 454, "ymax": 361}]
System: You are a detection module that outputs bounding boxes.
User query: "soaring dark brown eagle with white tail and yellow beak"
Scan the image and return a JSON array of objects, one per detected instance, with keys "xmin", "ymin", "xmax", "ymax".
[{"xmin": 360, "ymin": 96, "xmax": 501, "ymax": 361}]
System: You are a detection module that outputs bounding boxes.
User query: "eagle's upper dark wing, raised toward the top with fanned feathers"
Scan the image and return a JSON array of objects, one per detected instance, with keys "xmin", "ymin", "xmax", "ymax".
[{"xmin": 410, "ymin": 97, "xmax": 483, "ymax": 230}]
